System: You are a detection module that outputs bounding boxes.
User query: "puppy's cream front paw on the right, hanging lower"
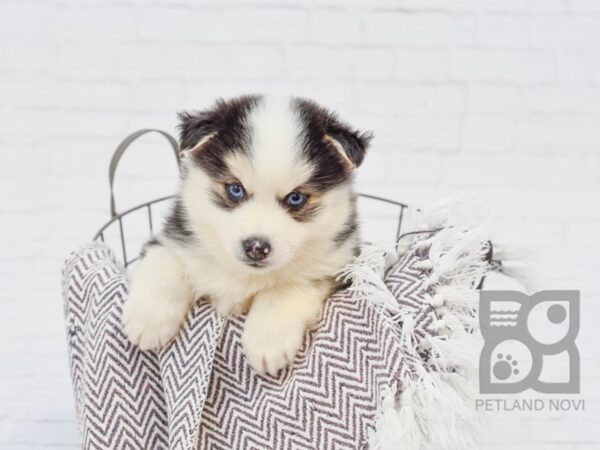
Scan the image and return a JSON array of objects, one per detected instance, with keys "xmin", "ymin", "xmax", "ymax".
[{"xmin": 242, "ymin": 314, "xmax": 304, "ymax": 376}]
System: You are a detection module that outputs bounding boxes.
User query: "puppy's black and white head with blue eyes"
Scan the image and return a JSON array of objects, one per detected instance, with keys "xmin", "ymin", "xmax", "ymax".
[{"xmin": 181, "ymin": 97, "xmax": 369, "ymax": 273}]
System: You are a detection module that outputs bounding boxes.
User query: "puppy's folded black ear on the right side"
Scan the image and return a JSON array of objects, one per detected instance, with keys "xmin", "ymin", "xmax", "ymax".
[{"xmin": 323, "ymin": 123, "xmax": 373, "ymax": 170}]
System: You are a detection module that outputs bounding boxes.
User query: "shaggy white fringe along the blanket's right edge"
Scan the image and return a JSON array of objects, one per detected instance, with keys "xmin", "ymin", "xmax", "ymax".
[{"xmin": 340, "ymin": 200, "xmax": 532, "ymax": 450}]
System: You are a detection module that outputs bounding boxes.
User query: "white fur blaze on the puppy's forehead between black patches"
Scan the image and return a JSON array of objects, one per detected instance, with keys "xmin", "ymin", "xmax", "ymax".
[{"xmin": 248, "ymin": 96, "xmax": 313, "ymax": 188}]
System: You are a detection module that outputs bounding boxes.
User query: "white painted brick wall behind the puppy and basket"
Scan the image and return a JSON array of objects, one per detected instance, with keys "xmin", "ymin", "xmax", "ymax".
[{"xmin": 0, "ymin": 0, "xmax": 600, "ymax": 450}]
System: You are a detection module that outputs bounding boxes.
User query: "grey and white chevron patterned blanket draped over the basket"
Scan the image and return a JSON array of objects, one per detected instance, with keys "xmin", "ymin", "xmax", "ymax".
[{"xmin": 63, "ymin": 234, "xmax": 450, "ymax": 450}]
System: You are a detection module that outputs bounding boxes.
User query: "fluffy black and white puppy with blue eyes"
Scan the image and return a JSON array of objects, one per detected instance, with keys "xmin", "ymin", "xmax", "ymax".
[{"xmin": 123, "ymin": 96, "xmax": 371, "ymax": 375}]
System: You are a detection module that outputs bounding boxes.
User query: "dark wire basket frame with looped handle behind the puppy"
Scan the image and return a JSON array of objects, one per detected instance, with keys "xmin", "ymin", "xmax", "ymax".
[{"xmin": 94, "ymin": 129, "xmax": 407, "ymax": 267}]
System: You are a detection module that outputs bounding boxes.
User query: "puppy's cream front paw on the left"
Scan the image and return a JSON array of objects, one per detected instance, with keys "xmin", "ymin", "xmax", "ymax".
[{"xmin": 122, "ymin": 295, "xmax": 186, "ymax": 350}]
